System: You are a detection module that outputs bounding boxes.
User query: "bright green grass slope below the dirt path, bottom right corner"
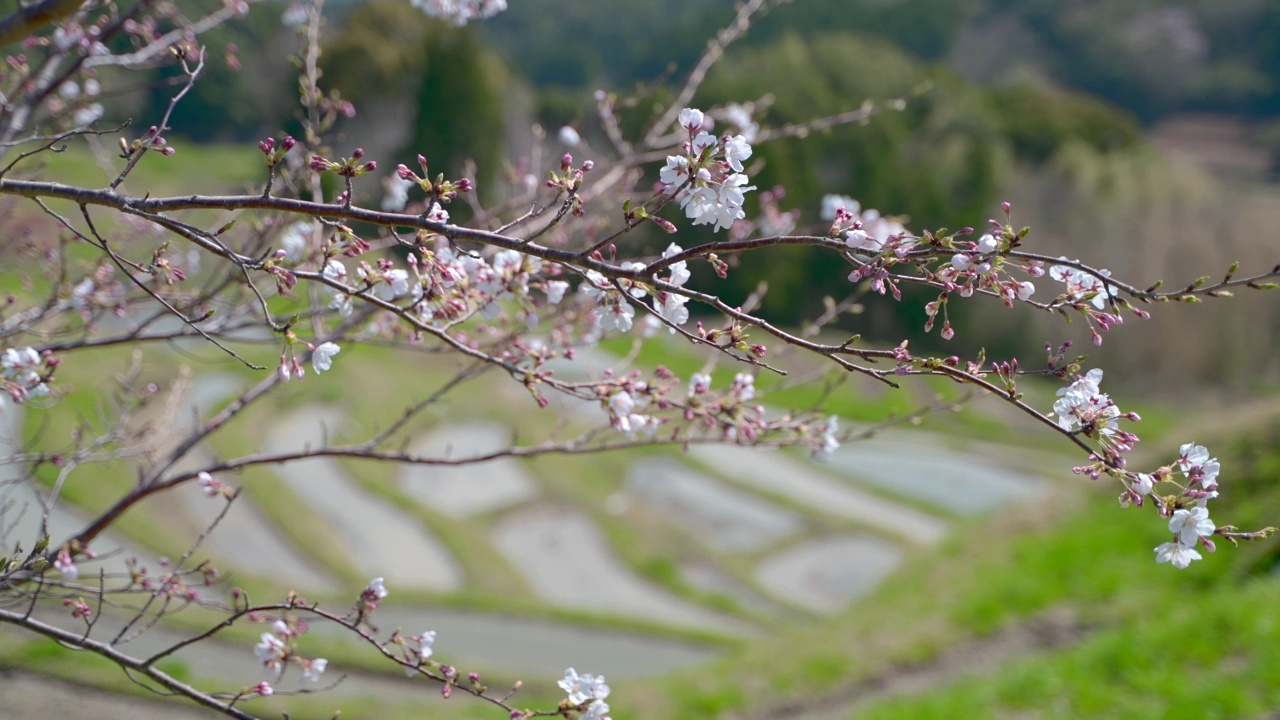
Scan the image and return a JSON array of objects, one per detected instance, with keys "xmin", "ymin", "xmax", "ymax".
[{"xmin": 858, "ymin": 580, "xmax": 1280, "ymax": 719}]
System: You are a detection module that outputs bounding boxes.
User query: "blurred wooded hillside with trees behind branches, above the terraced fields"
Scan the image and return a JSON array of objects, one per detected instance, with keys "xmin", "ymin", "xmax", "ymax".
[{"xmin": 104, "ymin": 0, "xmax": 1280, "ymax": 395}]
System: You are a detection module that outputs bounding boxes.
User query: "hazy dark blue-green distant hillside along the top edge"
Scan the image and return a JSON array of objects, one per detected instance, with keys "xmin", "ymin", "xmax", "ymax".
[{"xmin": 484, "ymin": 0, "xmax": 1280, "ymax": 122}]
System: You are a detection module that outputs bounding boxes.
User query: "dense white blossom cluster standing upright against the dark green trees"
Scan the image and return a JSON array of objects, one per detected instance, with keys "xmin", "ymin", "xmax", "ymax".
[{"xmin": 658, "ymin": 108, "xmax": 755, "ymax": 231}]
